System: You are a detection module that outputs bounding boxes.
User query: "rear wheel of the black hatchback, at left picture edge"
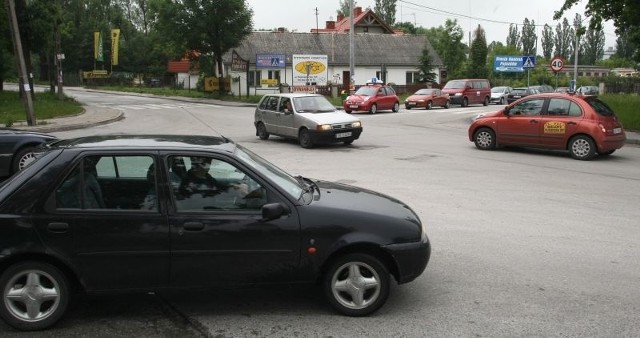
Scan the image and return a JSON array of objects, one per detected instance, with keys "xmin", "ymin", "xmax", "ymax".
[{"xmin": 0, "ymin": 261, "xmax": 70, "ymax": 331}]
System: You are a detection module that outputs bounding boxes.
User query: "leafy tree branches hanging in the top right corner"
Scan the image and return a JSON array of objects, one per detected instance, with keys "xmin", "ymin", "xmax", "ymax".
[{"xmin": 554, "ymin": 0, "xmax": 640, "ymax": 62}]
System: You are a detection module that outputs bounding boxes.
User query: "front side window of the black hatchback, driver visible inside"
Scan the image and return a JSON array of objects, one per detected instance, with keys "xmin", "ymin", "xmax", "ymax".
[{"xmin": 168, "ymin": 156, "xmax": 267, "ymax": 212}]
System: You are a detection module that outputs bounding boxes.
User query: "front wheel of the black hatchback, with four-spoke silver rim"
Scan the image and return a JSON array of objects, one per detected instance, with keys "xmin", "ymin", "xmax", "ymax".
[{"xmin": 322, "ymin": 253, "xmax": 390, "ymax": 317}]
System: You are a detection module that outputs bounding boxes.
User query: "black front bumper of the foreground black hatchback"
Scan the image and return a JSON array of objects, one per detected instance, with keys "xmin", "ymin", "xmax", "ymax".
[{"xmin": 383, "ymin": 236, "xmax": 431, "ymax": 284}]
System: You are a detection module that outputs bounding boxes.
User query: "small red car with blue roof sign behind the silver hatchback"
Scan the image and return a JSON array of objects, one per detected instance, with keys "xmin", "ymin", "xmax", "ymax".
[{"xmin": 343, "ymin": 83, "xmax": 400, "ymax": 114}]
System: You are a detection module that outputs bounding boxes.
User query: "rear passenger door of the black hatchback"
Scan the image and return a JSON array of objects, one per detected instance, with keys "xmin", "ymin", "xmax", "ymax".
[{"xmin": 45, "ymin": 154, "xmax": 169, "ymax": 291}]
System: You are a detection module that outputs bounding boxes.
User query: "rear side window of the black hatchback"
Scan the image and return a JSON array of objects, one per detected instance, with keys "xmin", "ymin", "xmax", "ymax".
[{"xmin": 55, "ymin": 155, "xmax": 158, "ymax": 210}]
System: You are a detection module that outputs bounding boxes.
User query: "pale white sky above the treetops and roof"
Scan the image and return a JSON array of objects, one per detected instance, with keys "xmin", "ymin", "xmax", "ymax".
[{"xmin": 246, "ymin": 0, "xmax": 616, "ymax": 50}]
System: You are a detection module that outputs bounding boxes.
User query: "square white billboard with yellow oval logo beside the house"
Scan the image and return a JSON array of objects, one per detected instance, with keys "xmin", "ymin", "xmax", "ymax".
[{"xmin": 292, "ymin": 54, "xmax": 329, "ymax": 86}]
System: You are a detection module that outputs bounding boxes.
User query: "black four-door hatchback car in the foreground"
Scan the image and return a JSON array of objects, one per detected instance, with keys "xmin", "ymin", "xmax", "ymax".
[{"xmin": 0, "ymin": 135, "xmax": 431, "ymax": 330}]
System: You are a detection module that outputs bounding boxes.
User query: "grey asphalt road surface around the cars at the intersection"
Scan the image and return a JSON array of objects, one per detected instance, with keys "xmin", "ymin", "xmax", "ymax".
[{"xmin": 0, "ymin": 93, "xmax": 640, "ymax": 337}]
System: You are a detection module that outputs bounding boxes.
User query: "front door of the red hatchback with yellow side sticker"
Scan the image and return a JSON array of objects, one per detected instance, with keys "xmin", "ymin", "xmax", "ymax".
[{"xmin": 496, "ymin": 99, "xmax": 544, "ymax": 146}]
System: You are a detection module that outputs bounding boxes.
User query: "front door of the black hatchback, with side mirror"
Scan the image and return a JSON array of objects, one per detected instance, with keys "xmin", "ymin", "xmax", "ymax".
[{"xmin": 169, "ymin": 155, "xmax": 300, "ymax": 287}]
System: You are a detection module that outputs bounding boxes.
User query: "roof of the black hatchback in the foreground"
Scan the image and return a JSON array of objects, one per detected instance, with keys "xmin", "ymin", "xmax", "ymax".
[{"xmin": 49, "ymin": 134, "xmax": 236, "ymax": 152}]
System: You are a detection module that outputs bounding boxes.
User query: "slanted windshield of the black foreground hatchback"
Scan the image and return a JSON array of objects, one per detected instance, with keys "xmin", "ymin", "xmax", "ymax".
[{"xmin": 236, "ymin": 144, "xmax": 305, "ymax": 199}]
